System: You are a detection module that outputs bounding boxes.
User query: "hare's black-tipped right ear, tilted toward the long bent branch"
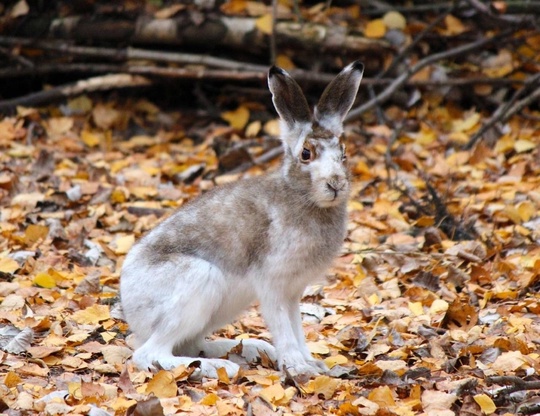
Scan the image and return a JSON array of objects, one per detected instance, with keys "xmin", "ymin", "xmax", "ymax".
[{"xmin": 315, "ymin": 61, "xmax": 364, "ymax": 136}]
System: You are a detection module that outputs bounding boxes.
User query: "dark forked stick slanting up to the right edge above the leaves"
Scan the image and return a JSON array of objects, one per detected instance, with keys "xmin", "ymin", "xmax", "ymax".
[{"xmin": 465, "ymin": 73, "xmax": 540, "ymax": 149}]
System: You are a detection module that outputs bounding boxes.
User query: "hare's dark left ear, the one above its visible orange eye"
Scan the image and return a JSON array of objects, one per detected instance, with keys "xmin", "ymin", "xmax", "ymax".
[{"xmin": 268, "ymin": 66, "xmax": 312, "ymax": 136}]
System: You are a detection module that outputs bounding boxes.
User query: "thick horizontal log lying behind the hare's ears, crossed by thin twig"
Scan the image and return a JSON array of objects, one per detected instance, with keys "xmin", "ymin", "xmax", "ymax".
[{"xmin": 7, "ymin": 13, "xmax": 390, "ymax": 55}]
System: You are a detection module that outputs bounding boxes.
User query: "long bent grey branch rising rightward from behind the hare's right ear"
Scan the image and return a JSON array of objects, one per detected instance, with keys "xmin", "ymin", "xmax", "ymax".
[{"xmin": 346, "ymin": 30, "xmax": 511, "ymax": 121}]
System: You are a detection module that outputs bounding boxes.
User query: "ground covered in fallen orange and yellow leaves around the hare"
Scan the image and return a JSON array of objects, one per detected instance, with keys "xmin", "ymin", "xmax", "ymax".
[{"xmin": 0, "ymin": 97, "xmax": 540, "ymax": 416}]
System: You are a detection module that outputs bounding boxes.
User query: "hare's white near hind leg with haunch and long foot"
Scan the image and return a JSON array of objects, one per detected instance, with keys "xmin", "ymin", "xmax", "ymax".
[{"xmin": 125, "ymin": 256, "xmax": 239, "ymax": 377}]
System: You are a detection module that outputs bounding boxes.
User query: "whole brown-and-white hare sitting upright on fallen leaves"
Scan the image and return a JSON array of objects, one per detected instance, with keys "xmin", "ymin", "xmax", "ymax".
[{"xmin": 120, "ymin": 62, "xmax": 363, "ymax": 377}]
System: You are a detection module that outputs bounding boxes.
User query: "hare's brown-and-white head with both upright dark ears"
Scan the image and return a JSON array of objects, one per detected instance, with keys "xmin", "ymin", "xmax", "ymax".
[{"xmin": 268, "ymin": 61, "xmax": 364, "ymax": 208}]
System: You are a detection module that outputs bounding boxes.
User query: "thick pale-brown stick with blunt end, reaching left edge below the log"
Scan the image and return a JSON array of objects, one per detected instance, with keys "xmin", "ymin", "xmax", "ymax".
[{"xmin": 0, "ymin": 74, "xmax": 151, "ymax": 111}]
